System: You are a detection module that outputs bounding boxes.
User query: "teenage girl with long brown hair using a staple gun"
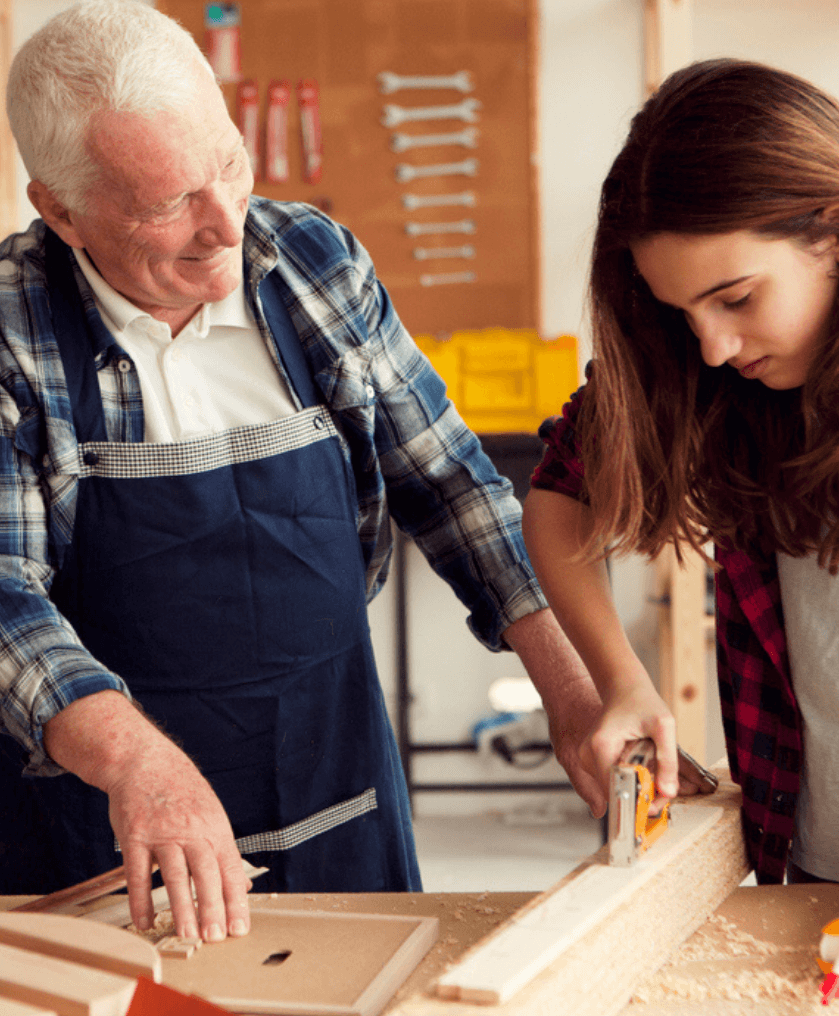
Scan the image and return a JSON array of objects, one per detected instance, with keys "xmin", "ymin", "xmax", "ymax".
[{"xmin": 525, "ymin": 60, "xmax": 839, "ymax": 883}]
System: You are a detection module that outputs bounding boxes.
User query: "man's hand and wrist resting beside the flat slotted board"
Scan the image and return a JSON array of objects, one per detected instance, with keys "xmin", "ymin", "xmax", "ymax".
[{"xmin": 45, "ymin": 692, "xmax": 250, "ymax": 942}]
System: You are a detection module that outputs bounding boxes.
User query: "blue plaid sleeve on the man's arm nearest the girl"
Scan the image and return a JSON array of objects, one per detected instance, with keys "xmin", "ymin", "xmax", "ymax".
[{"xmin": 337, "ymin": 225, "xmax": 546, "ymax": 651}]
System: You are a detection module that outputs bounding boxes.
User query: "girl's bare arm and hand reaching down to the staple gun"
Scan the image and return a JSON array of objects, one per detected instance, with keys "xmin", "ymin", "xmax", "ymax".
[{"xmin": 523, "ymin": 488, "xmax": 679, "ymax": 798}]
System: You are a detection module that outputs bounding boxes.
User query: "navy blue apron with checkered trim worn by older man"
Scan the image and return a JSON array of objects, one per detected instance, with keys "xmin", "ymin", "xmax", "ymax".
[{"xmin": 0, "ymin": 230, "xmax": 421, "ymax": 893}]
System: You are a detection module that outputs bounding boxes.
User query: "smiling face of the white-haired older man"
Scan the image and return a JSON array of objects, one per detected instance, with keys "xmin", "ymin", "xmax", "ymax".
[{"xmin": 59, "ymin": 69, "xmax": 253, "ymax": 333}]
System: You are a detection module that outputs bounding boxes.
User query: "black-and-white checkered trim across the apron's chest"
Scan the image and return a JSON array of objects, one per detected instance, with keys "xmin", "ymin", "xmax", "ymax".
[{"xmin": 78, "ymin": 405, "xmax": 337, "ymax": 480}]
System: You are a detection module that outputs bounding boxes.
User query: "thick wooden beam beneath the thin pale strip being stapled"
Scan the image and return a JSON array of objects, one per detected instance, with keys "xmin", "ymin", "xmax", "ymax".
[{"xmin": 389, "ymin": 767, "xmax": 749, "ymax": 1016}]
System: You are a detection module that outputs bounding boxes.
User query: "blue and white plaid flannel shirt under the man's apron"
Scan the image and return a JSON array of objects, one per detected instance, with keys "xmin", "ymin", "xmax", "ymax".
[{"xmin": 0, "ymin": 197, "xmax": 545, "ymax": 775}]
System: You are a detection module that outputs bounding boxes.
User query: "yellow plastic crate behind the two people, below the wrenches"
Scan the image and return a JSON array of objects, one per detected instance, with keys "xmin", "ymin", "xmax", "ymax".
[{"xmin": 414, "ymin": 328, "xmax": 579, "ymax": 434}]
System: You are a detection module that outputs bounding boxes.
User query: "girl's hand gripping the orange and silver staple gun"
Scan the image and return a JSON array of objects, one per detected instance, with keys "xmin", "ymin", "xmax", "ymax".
[{"xmin": 580, "ymin": 674, "xmax": 679, "ymax": 818}]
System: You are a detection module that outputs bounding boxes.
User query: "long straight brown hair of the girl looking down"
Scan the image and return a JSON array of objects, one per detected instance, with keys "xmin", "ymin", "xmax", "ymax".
[{"xmin": 580, "ymin": 60, "xmax": 839, "ymax": 570}]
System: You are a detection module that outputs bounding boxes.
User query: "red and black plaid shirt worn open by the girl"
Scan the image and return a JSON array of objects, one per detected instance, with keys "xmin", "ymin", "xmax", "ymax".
[{"xmin": 531, "ymin": 373, "xmax": 801, "ymax": 884}]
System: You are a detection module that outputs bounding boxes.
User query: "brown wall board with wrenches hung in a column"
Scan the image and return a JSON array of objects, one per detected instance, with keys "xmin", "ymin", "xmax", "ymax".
[{"xmin": 157, "ymin": 0, "xmax": 539, "ymax": 334}]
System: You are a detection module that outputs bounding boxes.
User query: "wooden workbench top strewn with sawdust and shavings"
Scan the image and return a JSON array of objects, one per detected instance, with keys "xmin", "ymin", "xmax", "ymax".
[{"xmin": 0, "ymin": 885, "xmax": 839, "ymax": 1016}]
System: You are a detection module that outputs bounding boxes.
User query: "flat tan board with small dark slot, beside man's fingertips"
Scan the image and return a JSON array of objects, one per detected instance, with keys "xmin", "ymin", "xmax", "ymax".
[{"xmin": 164, "ymin": 908, "xmax": 438, "ymax": 1016}]
